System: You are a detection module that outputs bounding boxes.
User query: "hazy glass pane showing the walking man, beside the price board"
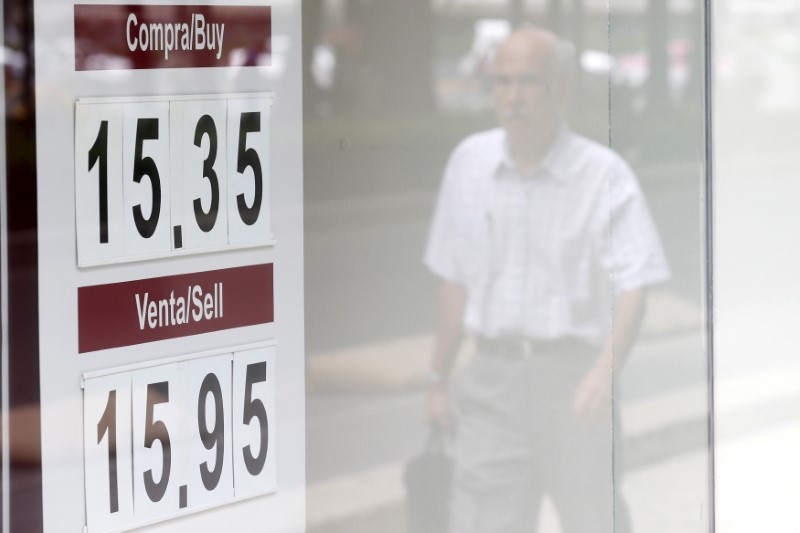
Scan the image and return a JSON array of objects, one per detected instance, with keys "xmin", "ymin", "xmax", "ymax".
[{"xmin": 304, "ymin": 2, "xmax": 709, "ymax": 533}]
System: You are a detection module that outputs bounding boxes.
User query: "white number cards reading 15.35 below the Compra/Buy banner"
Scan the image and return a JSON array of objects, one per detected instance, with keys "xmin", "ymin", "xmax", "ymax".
[{"xmin": 75, "ymin": 97, "xmax": 272, "ymax": 266}]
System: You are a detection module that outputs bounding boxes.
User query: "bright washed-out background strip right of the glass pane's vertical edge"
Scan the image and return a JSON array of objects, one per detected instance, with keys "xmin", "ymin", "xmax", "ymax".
[{"xmin": 713, "ymin": 0, "xmax": 800, "ymax": 533}]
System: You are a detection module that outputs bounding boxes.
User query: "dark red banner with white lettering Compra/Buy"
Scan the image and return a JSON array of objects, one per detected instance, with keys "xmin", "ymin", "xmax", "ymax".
[{"xmin": 75, "ymin": 4, "xmax": 272, "ymax": 71}]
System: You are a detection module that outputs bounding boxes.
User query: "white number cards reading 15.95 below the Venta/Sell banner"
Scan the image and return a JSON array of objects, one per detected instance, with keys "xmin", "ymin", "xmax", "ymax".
[{"xmin": 83, "ymin": 346, "xmax": 277, "ymax": 533}]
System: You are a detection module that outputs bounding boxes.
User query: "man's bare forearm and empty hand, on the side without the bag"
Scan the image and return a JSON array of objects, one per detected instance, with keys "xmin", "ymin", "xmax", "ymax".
[{"xmin": 574, "ymin": 288, "xmax": 646, "ymax": 419}]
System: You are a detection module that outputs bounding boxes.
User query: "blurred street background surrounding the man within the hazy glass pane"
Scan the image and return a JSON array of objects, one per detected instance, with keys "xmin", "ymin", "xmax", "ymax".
[{"xmin": 303, "ymin": 0, "xmax": 712, "ymax": 533}]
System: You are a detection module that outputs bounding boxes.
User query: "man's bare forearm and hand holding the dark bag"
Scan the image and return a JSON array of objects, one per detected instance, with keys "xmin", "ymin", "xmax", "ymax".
[{"xmin": 428, "ymin": 281, "xmax": 467, "ymax": 428}]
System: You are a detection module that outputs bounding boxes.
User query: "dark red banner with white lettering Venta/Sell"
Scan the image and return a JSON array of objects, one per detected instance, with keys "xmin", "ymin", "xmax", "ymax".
[{"xmin": 78, "ymin": 264, "xmax": 275, "ymax": 353}]
